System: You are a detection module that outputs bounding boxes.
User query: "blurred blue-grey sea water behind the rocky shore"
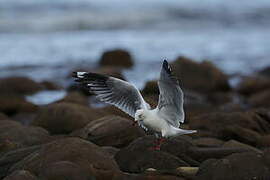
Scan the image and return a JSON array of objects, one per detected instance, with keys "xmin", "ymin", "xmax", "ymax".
[{"xmin": 0, "ymin": 0, "xmax": 270, "ymax": 104}]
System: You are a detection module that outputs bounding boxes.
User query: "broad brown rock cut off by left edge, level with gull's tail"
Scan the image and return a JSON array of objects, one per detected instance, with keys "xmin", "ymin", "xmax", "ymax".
[{"xmin": 0, "ymin": 120, "xmax": 51, "ymax": 147}]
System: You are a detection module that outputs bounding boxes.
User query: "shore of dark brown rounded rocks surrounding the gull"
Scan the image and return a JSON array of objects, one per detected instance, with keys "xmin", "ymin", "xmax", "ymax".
[{"xmin": 0, "ymin": 50, "xmax": 270, "ymax": 180}]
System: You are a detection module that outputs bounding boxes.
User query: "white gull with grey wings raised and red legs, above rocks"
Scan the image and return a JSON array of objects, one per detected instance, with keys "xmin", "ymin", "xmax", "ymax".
[{"xmin": 74, "ymin": 60, "xmax": 196, "ymax": 149}]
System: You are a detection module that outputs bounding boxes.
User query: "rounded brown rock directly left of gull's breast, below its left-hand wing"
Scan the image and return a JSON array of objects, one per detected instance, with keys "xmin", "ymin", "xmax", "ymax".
[{"xmin": 72, "ymin": 116, "xmax": 144, "ymax": 147}]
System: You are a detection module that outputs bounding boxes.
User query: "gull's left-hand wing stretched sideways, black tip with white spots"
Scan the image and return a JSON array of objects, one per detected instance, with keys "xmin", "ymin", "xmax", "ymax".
[{"xmin": 73, "ymin": 72, "xmax": 150, "ymax": 117}]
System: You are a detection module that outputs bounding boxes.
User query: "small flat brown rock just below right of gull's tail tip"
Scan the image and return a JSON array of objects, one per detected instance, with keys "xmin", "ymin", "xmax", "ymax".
[{"xmin": 193, "ymin": 137, "xmax": 224, "ymax": 147}]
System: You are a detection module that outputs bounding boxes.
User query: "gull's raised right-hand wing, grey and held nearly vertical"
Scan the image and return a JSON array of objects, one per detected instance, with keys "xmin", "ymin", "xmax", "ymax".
[{"xmin": 157, "ymin": 60, "xmax": 185, "ymax": 127}]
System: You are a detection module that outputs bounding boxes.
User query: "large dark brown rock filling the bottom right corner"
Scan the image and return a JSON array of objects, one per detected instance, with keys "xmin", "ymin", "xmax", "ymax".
[{"xmin": 196, "ymin": 152, "xmax": 270, "ymax": 180}]
